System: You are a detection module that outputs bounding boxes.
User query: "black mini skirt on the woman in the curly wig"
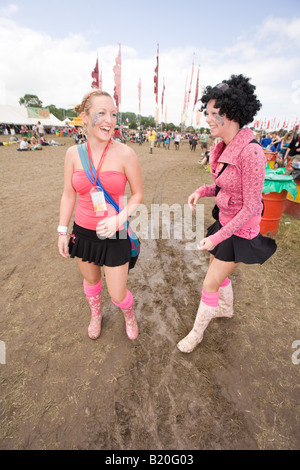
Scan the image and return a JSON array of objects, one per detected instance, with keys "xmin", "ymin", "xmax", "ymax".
[{"xmin": 206, "ymin": 220, "xmax": 277, "ymax": 264}]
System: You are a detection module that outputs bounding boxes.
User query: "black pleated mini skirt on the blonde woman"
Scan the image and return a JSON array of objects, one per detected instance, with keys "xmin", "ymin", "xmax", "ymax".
[{"xmin": 69, "ymin": 223, "xmax": 131, "ymax": 267}]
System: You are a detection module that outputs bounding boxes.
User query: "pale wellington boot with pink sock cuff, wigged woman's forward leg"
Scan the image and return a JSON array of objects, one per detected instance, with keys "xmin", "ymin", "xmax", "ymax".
[{"xmin": 177, "ymin": 289, "xmax": 219, "ymax": 353}]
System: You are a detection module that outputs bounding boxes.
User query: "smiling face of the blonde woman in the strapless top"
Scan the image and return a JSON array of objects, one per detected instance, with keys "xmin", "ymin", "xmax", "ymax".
[{"xmin": 82, "ymin": 95, "xmax": 117, "ymax": 141}]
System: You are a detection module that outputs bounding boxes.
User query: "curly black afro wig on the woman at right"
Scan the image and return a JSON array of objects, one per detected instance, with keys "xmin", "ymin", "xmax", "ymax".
[{"xmin": 200, "ymin": 75, "xmax": 261, "ymax": 127}]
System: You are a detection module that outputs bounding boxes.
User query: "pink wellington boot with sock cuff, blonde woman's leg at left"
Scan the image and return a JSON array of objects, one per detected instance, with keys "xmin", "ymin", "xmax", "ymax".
[{"xmin": 83, "ymin": 280, "xmax": 102, "ymax": 339}]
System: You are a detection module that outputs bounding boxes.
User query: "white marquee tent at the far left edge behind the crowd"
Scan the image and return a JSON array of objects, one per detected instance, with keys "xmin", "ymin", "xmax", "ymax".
[{"xmin": 0, "ymin": 104, "xmax": 64, "ymax": 127}]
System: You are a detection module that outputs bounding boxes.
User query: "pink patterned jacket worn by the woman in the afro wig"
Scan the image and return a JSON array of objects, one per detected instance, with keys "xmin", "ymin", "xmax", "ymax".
[{"xmin": 196, "ymin": 128, "xmax": 266, "ymax": 246}]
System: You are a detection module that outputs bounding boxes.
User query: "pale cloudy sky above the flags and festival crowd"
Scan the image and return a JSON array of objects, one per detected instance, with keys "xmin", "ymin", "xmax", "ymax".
[{"xmin": 0, "ymin": 0, "xmax": 300, "ymax": 124}]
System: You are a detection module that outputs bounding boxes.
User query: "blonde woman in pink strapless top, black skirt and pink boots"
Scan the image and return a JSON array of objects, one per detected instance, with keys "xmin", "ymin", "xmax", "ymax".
[{"xmin": 58, "ymin": 90, "xmax": 143, "ymax": 340}]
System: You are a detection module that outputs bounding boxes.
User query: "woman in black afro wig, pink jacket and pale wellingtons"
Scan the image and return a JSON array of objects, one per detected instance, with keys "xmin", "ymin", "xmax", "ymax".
[{"xmin": 177, "ymin": 75, "xmax": 276, "ymax": 353}]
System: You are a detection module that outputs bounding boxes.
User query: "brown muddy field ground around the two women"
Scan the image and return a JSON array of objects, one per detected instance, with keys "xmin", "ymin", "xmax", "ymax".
[{"xmin": 0, "ymin": 136, "xmax": 300, "ymax": 450}]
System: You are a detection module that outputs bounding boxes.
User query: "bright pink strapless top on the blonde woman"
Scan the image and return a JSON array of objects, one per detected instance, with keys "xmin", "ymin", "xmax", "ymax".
[{"xmin": 72, "ymin": 170, "xmax": 127, "ymax": 230}]
